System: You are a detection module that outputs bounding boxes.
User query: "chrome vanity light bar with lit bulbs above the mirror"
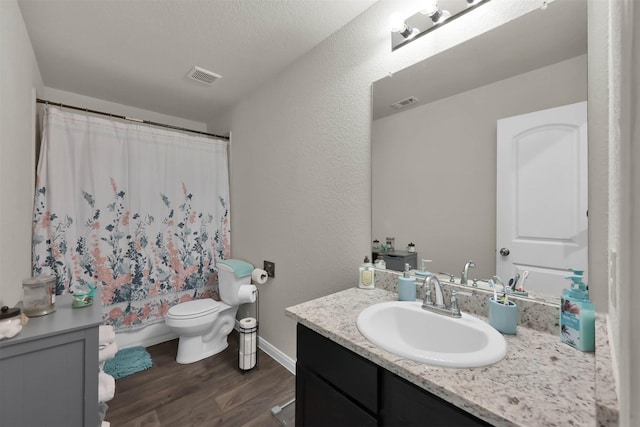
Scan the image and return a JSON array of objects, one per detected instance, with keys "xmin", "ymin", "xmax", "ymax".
[{"xmin": 389, "ymin": 0, "xmax": 489, "ymax": 51}]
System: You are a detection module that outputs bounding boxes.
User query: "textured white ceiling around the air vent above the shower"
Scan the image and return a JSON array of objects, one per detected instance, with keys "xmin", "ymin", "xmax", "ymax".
[{"xmin": 19, "ymin": 0, "xmax": 375, "ymax": 122}]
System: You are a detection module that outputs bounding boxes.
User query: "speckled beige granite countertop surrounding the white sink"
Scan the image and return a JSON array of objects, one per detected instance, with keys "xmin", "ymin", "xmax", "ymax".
[{"xmin": 286, "ymin": 288, "xmax": 596, "ymax": 426}]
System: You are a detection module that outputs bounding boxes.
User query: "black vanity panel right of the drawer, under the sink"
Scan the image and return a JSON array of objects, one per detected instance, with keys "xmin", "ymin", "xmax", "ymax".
[{"xmin": 380, "ymin": 371, "xmax": 491, "ymax": 427}]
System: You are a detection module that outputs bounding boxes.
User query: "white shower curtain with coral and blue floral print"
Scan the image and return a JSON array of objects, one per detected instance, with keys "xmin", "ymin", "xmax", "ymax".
[{"xmin": 33, "ymin": 107, "xmax": 230, "ymax": 330}]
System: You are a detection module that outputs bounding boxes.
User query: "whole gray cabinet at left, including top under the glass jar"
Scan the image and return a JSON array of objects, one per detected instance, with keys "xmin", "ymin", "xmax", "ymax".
[{"xmin": 0, "ymin": 295, "xmax": 102, "ymax": 427}]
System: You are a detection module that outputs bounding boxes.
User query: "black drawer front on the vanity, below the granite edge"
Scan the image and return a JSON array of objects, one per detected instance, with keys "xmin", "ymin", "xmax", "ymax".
[{"xmin": 297, "ymin": 323, "xmax": 378, "ymax": 414}]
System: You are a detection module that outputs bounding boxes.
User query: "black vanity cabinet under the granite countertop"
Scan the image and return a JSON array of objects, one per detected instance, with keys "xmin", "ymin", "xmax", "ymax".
[{"xmin": 296, "ymin": 324, "xmax": 490, "ymax": 427}]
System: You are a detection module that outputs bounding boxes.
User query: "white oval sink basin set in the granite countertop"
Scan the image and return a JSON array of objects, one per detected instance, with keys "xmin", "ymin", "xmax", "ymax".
[{"xmin": 357, "ymin": 301, "xmax": 507, "ymax": 368}]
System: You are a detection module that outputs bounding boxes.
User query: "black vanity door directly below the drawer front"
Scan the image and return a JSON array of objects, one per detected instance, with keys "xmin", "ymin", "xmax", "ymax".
[{"xmin": 296, "ymin": 364, "xmax": 378, "ymax": 427}]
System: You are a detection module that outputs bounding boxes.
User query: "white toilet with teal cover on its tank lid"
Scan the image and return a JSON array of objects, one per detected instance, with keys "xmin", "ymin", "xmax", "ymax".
[{"xmin": 165, "ymin": 259, "xmax": 256, "ymax": 364}]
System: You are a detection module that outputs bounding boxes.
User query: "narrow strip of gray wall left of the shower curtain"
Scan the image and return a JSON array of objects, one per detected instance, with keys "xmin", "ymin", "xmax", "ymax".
[{"xmin": 0, "ymin": 0, "xmax": 42, "ymax": 306}]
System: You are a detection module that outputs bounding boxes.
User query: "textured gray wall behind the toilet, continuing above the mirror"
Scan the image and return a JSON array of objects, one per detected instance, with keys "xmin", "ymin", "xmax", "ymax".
[{"xmin": 210, "ymin": 0, "xmax": 540, "ymax": 358}]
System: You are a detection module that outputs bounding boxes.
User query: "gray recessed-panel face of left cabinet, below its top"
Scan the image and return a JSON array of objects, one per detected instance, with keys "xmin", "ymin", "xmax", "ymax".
[{"xmin": 0, "ymin": 327, "xmax": 99, "ymax": 427}]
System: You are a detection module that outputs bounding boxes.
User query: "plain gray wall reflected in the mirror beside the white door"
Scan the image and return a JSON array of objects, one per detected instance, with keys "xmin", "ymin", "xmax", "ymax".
[{"xmin": 371, "ymin": 55, "xmax": 587, "ymax": 279}]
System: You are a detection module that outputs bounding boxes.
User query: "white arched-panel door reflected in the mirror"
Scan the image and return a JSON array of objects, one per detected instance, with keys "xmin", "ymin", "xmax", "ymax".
[{"xmin": 496, "ymin": 102, "xmax": 588, "ymax": 296}]
